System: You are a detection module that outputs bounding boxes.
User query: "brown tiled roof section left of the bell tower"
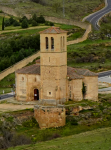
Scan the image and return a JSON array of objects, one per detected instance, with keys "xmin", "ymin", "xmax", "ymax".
[{"xmin": 16, "ymin": 64, "xmax": 40, "ymax": 75}]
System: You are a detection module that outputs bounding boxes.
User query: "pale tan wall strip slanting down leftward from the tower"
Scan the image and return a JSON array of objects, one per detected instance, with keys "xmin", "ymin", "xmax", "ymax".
[{"xmin": 0, "ymin": 52, "xmax": 40, "ymax": 80}]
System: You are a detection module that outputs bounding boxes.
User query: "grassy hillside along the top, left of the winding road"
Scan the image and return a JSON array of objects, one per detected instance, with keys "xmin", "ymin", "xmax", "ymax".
[{"xmin": 0, "ymin": 0, "xmax": 104, "ymax": 20}]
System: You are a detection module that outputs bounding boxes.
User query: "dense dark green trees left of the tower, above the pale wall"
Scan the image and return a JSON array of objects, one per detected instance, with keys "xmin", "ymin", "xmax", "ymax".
[{"xmin": 0, "ymin": 35, "xmax": 40, "ymax": 71}]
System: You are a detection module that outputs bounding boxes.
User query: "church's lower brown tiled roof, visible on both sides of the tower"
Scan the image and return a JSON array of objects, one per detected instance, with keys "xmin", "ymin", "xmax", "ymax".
[{"xmin": 16, "ymin": 64, "xmax": 98, "ymax": 80}]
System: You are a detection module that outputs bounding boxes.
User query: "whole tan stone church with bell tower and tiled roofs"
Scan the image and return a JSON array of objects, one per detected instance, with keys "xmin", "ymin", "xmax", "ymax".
[{"xmin": 16, "ymin": 27, "xmax": 98, "ymax": 104}]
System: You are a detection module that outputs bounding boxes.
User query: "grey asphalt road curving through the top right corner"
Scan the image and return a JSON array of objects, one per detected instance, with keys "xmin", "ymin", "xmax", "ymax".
[{"xmin": 86, "ymin": 0, "xmax": 111, "ymax": 30}]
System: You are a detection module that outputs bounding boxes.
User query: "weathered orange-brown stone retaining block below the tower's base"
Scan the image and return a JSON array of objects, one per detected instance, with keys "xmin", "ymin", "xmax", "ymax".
[{"xmin": 34, "ymin": 105, "xmax": 66, "ymax": 129}]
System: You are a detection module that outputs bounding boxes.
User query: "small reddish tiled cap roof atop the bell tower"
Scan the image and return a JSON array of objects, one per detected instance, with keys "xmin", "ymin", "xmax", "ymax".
[{"xmin": 39, "ymin": 26, "xmax": 67, "ymax": 34}]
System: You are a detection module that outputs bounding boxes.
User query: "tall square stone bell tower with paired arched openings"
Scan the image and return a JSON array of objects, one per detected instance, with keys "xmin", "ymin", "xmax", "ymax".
[{"xmin": 40, "ymin": 27, "xmax": 67, "ymax": 103}]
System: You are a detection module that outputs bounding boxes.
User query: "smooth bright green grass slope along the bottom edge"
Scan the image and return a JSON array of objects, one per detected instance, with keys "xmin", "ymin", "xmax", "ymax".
[{"xmin": 8, "ymin": 127, "xmax": 111, "ymax": 150}]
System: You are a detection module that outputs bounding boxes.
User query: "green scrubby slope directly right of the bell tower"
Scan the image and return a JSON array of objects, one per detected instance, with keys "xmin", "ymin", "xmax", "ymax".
[{"xmin": 68, "ymin": 39, "xmax": 111, "ymax": 72}]
